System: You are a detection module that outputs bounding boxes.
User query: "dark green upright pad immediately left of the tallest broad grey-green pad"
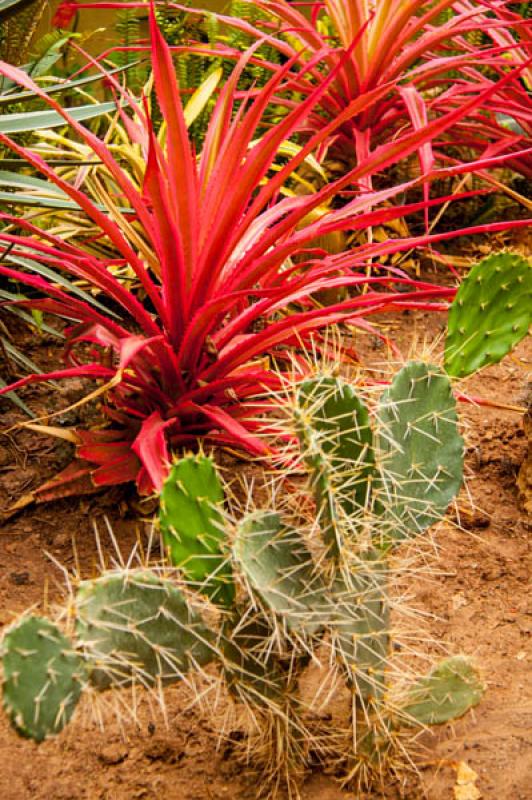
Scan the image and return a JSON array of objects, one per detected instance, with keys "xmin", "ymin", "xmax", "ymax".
[{"xmin": 294, "ymin": 375, "xmax": 375, "ymax": 553}]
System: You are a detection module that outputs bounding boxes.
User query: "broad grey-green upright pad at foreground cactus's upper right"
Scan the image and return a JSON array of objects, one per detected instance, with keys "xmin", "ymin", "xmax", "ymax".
[{"xmin": 376, "ymin": 361, "xmax": 464, "ymax": 541}]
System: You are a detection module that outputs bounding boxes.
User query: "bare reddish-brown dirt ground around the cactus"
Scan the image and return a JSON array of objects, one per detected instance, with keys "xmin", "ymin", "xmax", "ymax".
[{"xmin": 0, "ymin": 302, "xmax": 532, "ymax": 800}]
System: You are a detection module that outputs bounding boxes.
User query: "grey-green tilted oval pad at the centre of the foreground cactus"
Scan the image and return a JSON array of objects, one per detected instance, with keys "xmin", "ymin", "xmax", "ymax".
[{"xmin": 233, "ymin": 512, "xmax": 325, "ymax": 634}]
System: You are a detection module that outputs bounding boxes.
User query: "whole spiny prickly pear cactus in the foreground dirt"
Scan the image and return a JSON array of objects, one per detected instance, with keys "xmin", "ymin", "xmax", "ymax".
[{"xmin": 3, "ymin": 362, "xmax": 483, "ymax": 796}]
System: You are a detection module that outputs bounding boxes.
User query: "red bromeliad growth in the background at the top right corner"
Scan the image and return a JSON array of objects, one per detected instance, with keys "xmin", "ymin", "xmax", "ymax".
[{"xmin": 179, "ymin": 0, "xmax": 532, "ymax": 176}]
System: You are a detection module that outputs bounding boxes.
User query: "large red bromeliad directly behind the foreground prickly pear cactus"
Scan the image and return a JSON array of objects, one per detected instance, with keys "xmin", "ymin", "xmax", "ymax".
[{"xmin": 0, "ymin": 13, "xmax": 523, "ymax": 497}]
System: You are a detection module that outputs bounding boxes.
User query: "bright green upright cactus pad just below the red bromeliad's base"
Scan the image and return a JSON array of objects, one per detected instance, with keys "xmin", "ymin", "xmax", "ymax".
[{"xmin": 159, "ymin": 455, "xmax": 235, "ymax": 606}]
